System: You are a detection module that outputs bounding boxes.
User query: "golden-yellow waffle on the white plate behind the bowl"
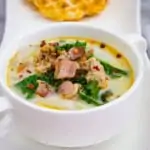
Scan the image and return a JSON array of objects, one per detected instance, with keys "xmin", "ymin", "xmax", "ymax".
[{"xmin": 28, "ymin": 0, "xmax": 107, "ymax": 21}]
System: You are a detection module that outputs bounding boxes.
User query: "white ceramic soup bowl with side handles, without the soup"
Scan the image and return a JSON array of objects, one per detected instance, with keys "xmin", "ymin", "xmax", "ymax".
[{"xmin": 0, "ymin": 23, "xmax": 146, "ymax": 147}]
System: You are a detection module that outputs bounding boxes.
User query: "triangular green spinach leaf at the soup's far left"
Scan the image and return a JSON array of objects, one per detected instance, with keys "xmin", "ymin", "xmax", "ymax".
[{"xmin": 15, "ymin": 75, "xmax": 38, "ymax": 99}]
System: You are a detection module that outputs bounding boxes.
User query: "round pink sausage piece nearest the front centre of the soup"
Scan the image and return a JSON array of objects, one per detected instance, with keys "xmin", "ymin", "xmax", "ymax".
[{"xmin": 58, "ymin": 81, "xmax": 79, "ymax": 98}]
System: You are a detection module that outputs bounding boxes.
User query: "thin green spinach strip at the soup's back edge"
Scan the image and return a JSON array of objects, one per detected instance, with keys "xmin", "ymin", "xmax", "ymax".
[{"xmin": 56, "ymin": 41, "xmax": 86, "ymax": 51}]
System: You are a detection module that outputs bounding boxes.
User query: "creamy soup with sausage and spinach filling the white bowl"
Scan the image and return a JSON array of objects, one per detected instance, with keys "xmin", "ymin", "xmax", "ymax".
[{"xmin": 7, "ymin": 37, "xmax": 134, "ymax": 110}]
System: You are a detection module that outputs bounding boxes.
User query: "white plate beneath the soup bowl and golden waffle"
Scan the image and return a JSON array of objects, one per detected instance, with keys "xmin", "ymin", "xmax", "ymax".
[{"xmin": 0, "ymin": 0, "xmax": 150, "ymax": 150}]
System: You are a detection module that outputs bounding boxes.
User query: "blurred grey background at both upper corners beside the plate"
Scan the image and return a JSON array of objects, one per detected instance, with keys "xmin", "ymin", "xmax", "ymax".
[{"xmin": 0, "ymin": 0, "xmax": 150, "ymax": 56}]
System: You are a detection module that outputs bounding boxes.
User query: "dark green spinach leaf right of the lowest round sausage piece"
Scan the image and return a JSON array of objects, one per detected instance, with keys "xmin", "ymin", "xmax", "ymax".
[{"xmin": 79, "ymin": 80, "xmax": 102, "ymax": 106}]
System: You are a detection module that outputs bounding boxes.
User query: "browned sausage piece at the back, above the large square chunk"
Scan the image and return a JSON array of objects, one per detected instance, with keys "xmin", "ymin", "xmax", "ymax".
[{"xmin": 68, "ymin": 47, "xmax": 85, "ymax": 60}]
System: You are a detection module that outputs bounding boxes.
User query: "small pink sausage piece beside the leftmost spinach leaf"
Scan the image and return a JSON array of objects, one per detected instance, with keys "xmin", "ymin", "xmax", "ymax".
[{"xmin": 36, "ymin": 81, "xmax": 52, "ymax": 97}]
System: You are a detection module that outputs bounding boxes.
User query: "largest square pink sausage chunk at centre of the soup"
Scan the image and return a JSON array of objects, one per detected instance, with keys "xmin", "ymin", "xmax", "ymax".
[{"xmin": 55, "ymin": 59, "xmax": 79, "ymax": 79}]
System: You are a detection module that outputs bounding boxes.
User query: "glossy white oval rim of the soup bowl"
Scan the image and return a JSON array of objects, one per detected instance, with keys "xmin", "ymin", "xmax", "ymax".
[{"xmin": 0, "ymin": 22, "xmax": 144, "ymax": 115}]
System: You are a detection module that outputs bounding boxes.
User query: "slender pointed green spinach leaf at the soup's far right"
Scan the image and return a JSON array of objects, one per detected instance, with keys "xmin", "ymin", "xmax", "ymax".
[{"xmin": 100, "ymin": 60, "xmax": 128, "ymax": 78}]
